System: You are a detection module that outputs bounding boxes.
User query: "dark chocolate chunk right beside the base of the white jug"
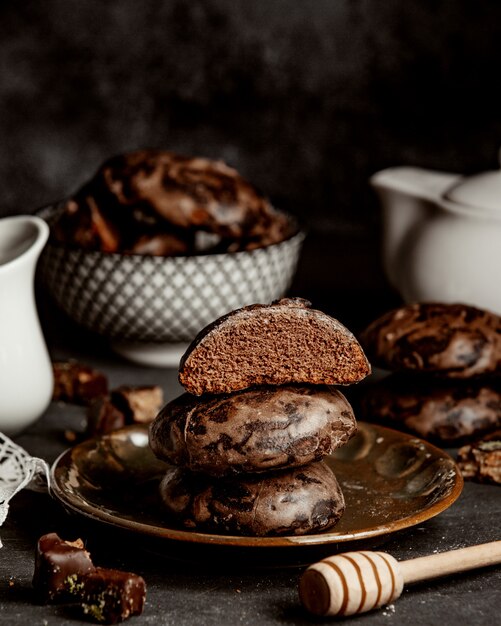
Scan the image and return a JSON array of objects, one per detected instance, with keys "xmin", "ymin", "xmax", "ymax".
[{"xmin": 52, "ymin": 361, "xmax": 108, "ymax": 405}]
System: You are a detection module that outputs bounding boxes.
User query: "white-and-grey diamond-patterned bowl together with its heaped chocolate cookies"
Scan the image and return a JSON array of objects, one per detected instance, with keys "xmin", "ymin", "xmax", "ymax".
[{"xmin": 39, "ymin": 150, "xmax": 304, "ymax": 365}]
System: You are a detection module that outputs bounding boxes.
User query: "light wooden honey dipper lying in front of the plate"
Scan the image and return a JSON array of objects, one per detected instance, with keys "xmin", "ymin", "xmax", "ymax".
[{"xmin": 299, "ymin": 541, "xmax": 501, "ymax": 615}]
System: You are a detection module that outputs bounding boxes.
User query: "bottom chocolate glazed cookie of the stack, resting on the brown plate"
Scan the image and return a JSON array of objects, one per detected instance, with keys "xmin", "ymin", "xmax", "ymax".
[{"xmin": 160, "ymin": 462, "xmax": 345, "ymax": 536}]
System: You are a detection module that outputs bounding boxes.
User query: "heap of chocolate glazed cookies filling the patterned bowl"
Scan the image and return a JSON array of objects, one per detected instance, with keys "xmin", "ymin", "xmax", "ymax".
[{"xmin": 54, "ymin": 149, "xmax": 297, "ymax": 251}]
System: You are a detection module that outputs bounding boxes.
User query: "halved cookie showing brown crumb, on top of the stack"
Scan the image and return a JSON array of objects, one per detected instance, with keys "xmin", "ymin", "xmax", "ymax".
[{"xmin": 179, "ymin": 298, "xmax": 370, "ymax": 395}]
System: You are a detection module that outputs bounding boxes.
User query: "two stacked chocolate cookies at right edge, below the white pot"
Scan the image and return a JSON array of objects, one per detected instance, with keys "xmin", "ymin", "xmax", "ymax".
[{"xmin": 359, "ymin": 303, "xmax": 501, "ymax": 446}]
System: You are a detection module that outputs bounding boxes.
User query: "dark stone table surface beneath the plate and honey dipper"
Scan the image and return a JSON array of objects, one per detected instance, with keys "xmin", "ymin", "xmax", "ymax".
[{"xmin": 0, "ymin": 290, "xmax": 501, "ymax": 626}]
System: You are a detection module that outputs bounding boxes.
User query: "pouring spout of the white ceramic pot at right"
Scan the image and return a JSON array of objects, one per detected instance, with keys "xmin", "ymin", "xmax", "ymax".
[{"xmin": 369, "ymin": 166, "xmax": 462, "ymax": 202}]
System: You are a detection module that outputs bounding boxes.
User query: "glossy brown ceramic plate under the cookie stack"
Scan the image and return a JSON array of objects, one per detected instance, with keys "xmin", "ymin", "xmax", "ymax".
[{"xmin": 51, "ymin": 422, "xmax": 463, "ymax": 548}]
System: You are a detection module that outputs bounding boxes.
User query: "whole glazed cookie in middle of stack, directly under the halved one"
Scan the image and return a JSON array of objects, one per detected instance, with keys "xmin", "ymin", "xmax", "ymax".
[{"xmin": 150, "ymin": 385, "xmax": 356, "ymax": 476}]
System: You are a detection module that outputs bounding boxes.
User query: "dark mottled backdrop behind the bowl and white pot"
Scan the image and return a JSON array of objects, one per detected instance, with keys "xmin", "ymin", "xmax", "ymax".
[{"xmin": 0, "ymin": 0, "xmax": 501, "ymax": 320}]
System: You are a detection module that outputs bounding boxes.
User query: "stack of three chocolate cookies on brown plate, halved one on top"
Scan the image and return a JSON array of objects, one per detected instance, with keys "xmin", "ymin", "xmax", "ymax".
[{"xmin": 146, "ymin": 298, "xmax": 370, "ymax": 536}]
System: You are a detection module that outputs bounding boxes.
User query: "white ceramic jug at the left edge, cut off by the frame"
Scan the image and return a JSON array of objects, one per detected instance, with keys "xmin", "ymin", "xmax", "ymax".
[{"xmin": 0, "ymin": 215, "xmax": 53, "ymax": 435}]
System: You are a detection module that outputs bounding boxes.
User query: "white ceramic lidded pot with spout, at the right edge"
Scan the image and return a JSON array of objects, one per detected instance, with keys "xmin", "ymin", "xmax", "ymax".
[{"xmin": 370, "ymin": 154, "xmax": 501, "ymax": 314}]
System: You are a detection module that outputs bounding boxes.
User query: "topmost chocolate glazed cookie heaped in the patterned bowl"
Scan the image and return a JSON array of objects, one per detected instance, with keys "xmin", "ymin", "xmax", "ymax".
[{"xmin": 96, "ymin": 150, "xmax": 287, "ymax": 243}]
